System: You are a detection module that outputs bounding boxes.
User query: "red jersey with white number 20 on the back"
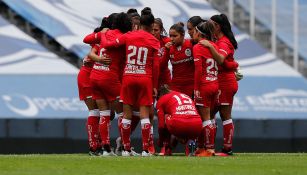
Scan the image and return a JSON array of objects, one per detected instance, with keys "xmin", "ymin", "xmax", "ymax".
[{"xmin": 102, "ymin": 30, "xmax": 160, "ymax": 87}]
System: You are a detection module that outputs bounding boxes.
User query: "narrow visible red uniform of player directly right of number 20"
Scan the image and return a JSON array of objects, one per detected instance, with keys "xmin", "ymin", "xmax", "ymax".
[{"xmin": 159, "ymin": 36, "xmax": 172, "ymax": 87}]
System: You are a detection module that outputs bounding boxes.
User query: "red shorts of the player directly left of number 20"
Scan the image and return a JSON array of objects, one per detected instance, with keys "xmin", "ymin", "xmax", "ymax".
[{"xmin": 91, "ymin": 78, "xmax": 121, "ymax": 102}]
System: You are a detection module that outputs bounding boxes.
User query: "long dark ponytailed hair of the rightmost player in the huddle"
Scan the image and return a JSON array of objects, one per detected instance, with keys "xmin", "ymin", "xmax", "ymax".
[{"xmin": 210, "ymin": 14, "xmax": 238, "ymax": 49}]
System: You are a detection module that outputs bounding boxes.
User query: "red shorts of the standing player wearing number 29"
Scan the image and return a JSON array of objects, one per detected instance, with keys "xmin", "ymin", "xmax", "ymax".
[{"xmin": 195, "ymin": 82, "xmax": 219, "ymax": 108}]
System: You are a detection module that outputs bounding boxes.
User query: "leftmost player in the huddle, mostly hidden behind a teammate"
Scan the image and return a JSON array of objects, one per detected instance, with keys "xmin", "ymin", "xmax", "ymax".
[{"xmin": 78, "ymin": 17, "xmax": 110, "ymax": 156}]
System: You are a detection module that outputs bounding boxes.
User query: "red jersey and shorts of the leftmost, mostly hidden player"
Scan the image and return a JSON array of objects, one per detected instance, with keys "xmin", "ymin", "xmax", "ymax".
[{"xmin": 78, "ymin": 44, "xmax": 99, "ymax": 100}]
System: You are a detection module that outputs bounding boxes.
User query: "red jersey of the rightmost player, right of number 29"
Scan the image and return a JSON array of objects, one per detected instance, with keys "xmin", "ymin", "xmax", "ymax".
[{"xmin": 216, "ymin": 36, "xmax": 236, "ymax": 82}]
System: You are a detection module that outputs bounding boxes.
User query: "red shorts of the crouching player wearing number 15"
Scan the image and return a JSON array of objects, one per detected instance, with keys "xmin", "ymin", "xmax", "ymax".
[{"xmin": 165, "ymin": 116, "xmax": 203, "ymax": 139}]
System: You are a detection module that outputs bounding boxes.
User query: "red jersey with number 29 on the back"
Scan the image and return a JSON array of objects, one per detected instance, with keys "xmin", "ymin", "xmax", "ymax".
[{"xmin": 193, "ymin": 41, "xmax": 218, "ymax": 90}]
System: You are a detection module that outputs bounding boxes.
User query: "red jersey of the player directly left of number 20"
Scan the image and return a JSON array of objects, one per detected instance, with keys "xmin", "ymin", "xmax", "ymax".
[{"xmin": 91, "ymin": 29, "xmax": 125, "ymax": 80}]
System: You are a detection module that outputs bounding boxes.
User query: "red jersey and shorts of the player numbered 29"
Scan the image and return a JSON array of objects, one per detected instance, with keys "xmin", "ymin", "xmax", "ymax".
[{"xmin": 193, "ymin": 39, "xmax": 218, "ymax": 108}]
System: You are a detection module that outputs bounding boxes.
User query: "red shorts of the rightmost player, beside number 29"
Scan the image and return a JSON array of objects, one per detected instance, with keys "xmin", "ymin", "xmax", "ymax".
[{"xmin": 217, "ymin": 81, "xmax": 238, "ymax": 105}]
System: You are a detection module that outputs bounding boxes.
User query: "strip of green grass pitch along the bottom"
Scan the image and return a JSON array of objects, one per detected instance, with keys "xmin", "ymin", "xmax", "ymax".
[{"xmin": 0, "ymin": 153, "xmax": 307, "ymax": 175}]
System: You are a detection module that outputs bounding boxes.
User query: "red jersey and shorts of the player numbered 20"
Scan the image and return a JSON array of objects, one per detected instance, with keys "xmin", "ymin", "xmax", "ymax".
[{"xmin": 102, "ymin": 30, "xmax": 160, "ymax": 106}]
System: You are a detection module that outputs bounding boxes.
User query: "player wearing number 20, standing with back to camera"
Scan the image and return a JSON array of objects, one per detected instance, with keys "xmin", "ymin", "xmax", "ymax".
[{"xmin": 102, "ymin": 7, "xmax": 160, "ymax": 156}]
